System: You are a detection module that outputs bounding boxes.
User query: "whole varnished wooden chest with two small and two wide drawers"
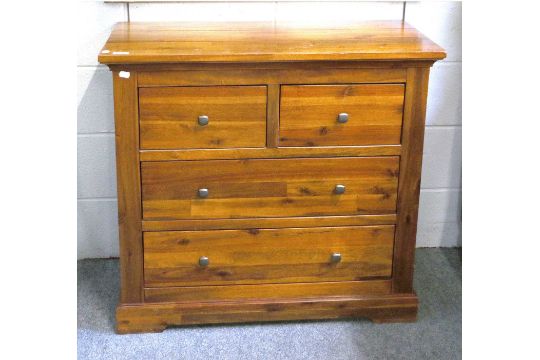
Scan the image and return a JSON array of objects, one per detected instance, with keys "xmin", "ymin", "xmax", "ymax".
[{"xmin": 99, "ymin": 21, "xmax": 445, "ymax": 333}]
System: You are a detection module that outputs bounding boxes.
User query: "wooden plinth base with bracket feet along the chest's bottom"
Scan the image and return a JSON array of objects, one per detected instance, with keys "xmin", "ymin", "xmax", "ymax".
[{"xmin": 116, "ymin": 294, "xmax": 418, "ymax": 334}]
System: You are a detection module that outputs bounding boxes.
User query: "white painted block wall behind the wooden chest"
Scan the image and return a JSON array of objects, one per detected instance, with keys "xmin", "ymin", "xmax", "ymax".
[{"xmin": 77, "ymin": 1, "xmax": 461, "ymax": 259}]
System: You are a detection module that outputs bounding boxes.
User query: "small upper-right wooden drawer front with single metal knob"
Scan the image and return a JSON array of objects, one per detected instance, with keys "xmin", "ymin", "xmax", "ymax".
[{"xmin": 279, "ymin": 84, "xmax": 405, "ymax": 146}]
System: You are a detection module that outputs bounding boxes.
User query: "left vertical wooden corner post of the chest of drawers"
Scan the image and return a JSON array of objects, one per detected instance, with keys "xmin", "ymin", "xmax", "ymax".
[{"xmin": 113, "ymin": 72, "xmax": 143, "ymax": 304}]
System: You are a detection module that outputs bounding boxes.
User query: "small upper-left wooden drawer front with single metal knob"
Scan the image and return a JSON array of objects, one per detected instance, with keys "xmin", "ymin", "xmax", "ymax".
[{"xmin": 139, "ymin": 86, "xmax": 266, "ymax": 149}]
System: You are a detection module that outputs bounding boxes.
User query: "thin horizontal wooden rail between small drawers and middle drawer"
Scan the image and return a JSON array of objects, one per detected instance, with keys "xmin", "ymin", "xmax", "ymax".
[{"xmin": 140, "ymin": 145, "xmax": 401, "ymax": 161}]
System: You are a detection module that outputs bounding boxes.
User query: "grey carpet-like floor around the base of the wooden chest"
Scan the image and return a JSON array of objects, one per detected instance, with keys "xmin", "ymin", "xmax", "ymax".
[{"xmin": 77, "ymin": 248, "xmax": 461, "ymax": 360}]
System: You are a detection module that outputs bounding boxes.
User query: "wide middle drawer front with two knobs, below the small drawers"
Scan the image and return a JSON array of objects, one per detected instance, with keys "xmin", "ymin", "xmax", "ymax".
[{"xmin": 141, "ymin": 156, "xmax": 399, "ymax": 220}]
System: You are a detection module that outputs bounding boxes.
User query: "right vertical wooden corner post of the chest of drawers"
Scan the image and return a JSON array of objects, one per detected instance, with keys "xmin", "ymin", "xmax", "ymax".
[{"xmin": 393, "ymin": 68, "xmax": 429, "ymax": 293}]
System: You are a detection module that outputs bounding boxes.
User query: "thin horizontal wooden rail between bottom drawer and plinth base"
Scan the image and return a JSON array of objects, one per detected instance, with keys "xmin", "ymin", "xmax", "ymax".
[{"xmin": 144, "ymin": 280, "xmax": 392, "ymax": 302}]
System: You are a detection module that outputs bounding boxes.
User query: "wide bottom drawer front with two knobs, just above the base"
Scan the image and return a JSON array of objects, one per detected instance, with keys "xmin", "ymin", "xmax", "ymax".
[{"xmin": 144, "ymin": 225, "xmax": 394, "ymax": 287}]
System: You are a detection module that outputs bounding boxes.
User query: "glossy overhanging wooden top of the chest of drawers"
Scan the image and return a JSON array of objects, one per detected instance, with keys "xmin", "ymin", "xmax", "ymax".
[{"xmin": 99, "ymin": 20, "xmax": 446, "ymax": 64}]
